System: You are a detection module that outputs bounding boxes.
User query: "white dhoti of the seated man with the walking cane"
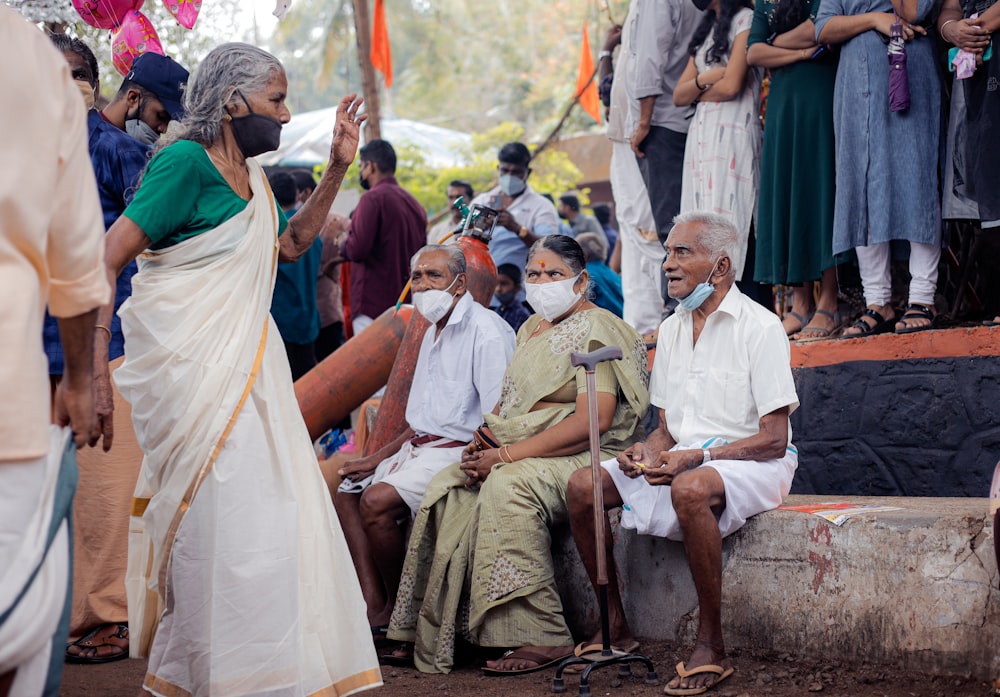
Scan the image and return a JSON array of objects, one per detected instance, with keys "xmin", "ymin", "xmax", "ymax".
[{"xmin": 601, "ymin": 444, "xmax": 799, "ymax": 542}]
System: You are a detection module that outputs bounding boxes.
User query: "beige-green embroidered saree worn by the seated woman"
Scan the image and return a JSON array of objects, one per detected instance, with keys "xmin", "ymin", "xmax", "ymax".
[{"xmin": 389, "ymin": 309, "xmax": 649, "ymax": 673}]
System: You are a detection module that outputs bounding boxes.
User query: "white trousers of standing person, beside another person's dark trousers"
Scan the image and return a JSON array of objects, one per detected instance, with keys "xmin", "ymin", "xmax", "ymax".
[{"xmin": 611, "ymin": 141, "xmax": 664, "ymax": 333}]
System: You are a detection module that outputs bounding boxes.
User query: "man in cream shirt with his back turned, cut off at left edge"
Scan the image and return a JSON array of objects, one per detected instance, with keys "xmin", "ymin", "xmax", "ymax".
[{"xmin": 0, "ymin": 7, "xmax": 111, "ymax": 697}]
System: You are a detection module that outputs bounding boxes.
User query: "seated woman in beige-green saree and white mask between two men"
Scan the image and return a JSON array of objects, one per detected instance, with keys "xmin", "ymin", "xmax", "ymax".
[{"xmin": 388, "ymin": 235, "xmax": 649, "ymax": 673}]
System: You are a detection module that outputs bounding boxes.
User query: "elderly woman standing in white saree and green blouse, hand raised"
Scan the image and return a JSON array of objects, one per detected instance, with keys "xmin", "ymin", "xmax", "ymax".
[{"xmin": 95, "ymin": 44, "xmax": 381, "ymax": 697}]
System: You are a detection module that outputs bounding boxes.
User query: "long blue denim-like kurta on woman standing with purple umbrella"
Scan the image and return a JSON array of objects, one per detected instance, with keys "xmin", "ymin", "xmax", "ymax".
[{"xmin": 816, "ymin": 0, "xmax": 941, "ymax": 254}]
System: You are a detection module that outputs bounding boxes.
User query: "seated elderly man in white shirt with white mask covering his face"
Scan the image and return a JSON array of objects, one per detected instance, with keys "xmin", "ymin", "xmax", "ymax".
[{"xmin": 334, "ymin": 245, "xmax": 514, "ymax": 640}]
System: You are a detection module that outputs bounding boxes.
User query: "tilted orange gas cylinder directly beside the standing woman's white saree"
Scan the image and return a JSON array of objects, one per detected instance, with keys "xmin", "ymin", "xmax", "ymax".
[{"xmin": 295, "ymin": 305, "xmax": 412, "ymax": 440}]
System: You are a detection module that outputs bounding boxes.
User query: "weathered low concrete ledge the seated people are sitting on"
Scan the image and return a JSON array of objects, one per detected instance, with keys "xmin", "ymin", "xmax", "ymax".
[{"xmin": 553, "ymin": 496, "xmax": 1000, "ymax": 680}]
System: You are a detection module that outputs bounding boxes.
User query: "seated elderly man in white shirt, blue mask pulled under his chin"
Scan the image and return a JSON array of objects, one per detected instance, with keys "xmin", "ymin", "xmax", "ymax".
[{"xmin": 568, "ymin": 212, "xmax": 799, "ymax": 695}]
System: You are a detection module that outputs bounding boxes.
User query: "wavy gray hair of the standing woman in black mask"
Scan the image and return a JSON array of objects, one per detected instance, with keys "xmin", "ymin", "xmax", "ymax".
[{"xmin": 157, "ymin": 43, "xmax": 284, "ymax": 150}]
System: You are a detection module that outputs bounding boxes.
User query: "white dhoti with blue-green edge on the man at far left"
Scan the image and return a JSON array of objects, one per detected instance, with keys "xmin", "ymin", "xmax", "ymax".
[{"xmin": 0, "ymin": 426, "xmax": 77, "ymax": 697}]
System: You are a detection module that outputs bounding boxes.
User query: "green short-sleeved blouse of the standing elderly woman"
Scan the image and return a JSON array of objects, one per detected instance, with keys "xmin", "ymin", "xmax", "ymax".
[{"xmin": 124, "ymin": 140, "xmax": 288, "ymax": 249}]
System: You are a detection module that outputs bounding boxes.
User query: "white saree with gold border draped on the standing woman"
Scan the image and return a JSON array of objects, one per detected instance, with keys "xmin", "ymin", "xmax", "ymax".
[{"xmin": 115, "ymin": 159, "xmax": 381, "ymax": 697}]
